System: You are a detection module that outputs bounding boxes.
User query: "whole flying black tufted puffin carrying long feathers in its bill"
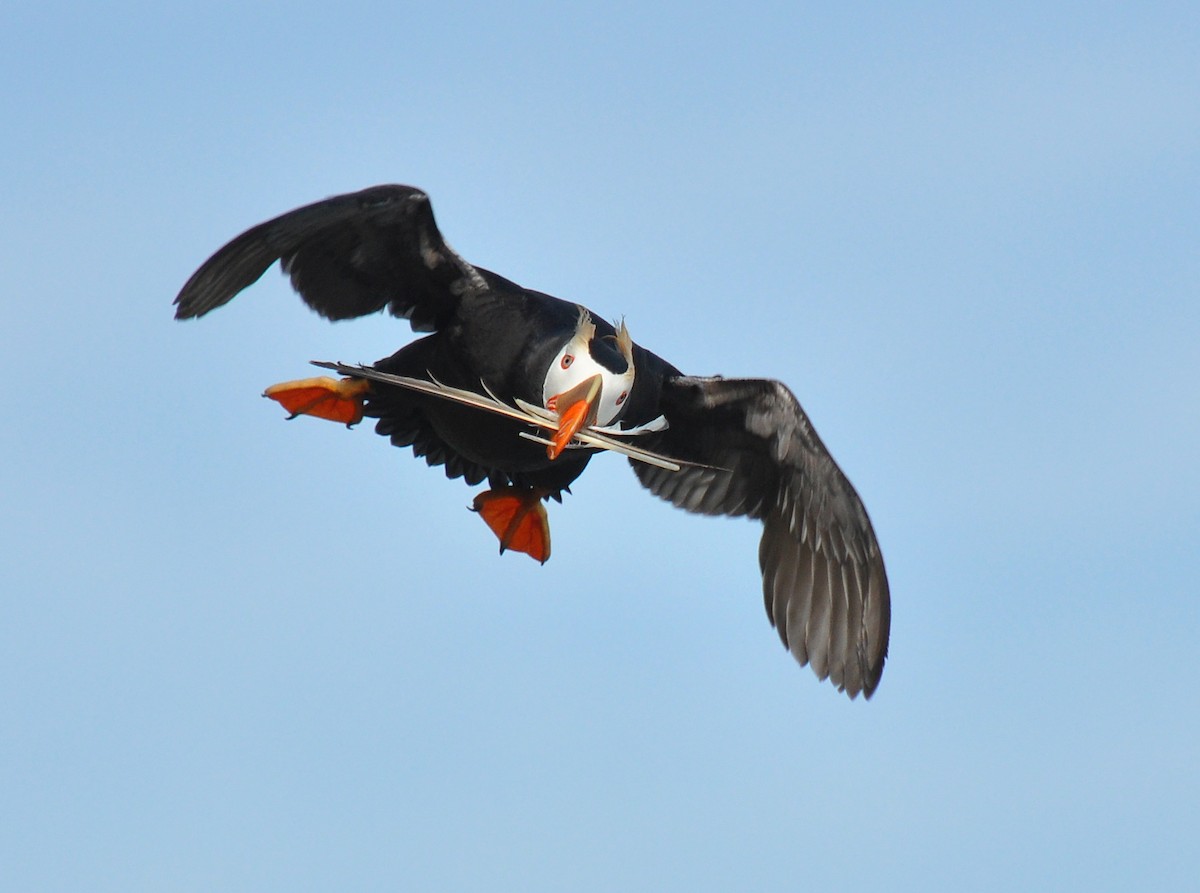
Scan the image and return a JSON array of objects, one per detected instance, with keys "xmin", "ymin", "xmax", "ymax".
[{"xmin": 175, "ymin": 186, "xmax": 890, "ymax": 699}]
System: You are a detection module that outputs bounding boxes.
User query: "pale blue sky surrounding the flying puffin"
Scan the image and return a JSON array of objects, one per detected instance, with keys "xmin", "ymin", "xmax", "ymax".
[{"xmin": 0, "ymin": 1, "xmax": 1200, "ymax": 891}]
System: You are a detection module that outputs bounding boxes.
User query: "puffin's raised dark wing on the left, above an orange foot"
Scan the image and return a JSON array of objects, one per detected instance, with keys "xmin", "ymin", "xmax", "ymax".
[{"xmin": 175, "ymin": 186, "xmax": 486, "ymax": 331}]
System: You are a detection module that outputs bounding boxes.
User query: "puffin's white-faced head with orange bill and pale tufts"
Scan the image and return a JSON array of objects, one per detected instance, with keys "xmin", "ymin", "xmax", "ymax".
[{"xmin": 542, "ymin": 307, "xmax": 635, "ymax": 459}]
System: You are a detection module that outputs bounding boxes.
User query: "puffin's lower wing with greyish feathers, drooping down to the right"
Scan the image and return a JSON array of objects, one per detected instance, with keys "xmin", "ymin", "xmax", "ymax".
[{"xmin": 632, "ymin": 377, "xmax": 892, "ymax": 697}]
